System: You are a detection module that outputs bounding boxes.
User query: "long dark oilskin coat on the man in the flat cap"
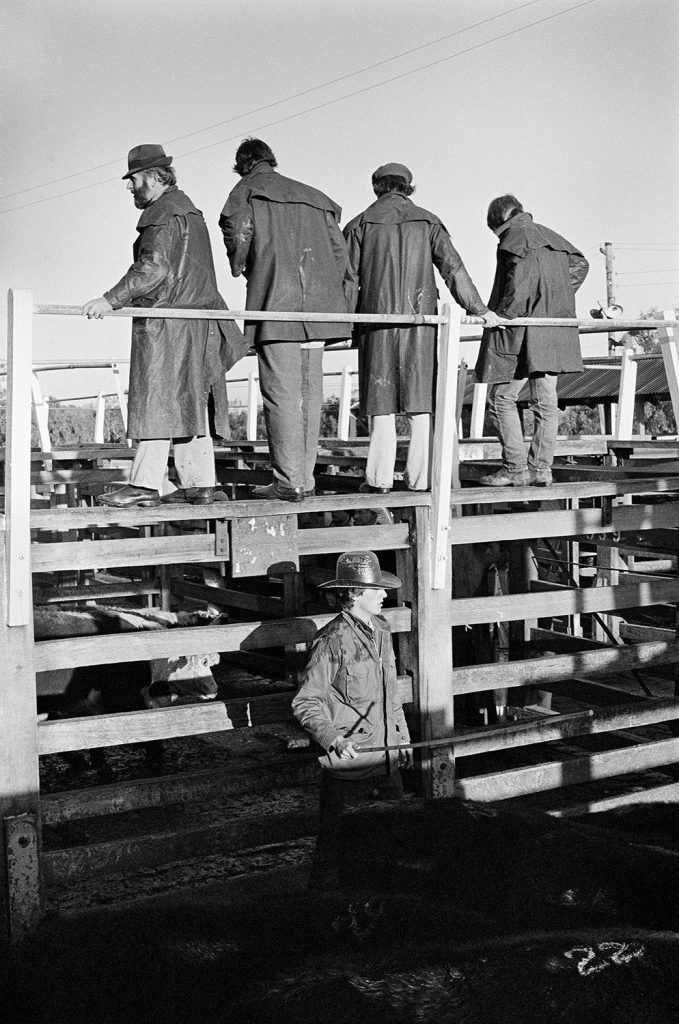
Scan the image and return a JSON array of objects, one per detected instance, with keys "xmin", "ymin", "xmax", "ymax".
[{"xmin": 344, "ymin": 193, "xmax": 487, "ymax": 416}]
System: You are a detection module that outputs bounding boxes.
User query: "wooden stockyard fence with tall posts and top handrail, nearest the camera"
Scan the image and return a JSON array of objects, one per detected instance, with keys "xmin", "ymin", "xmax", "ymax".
[{"xmin": 0, "ymin": 291, "xmax": 679, "ymax": 938}]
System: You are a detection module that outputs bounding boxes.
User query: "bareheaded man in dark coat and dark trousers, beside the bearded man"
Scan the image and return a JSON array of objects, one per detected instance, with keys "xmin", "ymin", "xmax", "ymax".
[{"xmin": 219, "ymin": 138, "xmax": 355, "ymax": 501}]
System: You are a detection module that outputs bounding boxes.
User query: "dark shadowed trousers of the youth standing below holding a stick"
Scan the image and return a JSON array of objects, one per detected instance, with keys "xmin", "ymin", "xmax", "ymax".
[{"xmin": 311, "ymin": 768, "xmax": 404, "ymax": 889}]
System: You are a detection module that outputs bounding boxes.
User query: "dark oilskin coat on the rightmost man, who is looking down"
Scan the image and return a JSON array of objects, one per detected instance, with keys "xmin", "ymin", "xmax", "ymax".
[{"xmin": 476, "ymin": 213, "xmax": 589, "ymax": 384}]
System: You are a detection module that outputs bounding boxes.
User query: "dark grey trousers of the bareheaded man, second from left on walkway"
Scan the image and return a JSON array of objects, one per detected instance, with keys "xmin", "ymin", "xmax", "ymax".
[{"xmin": 257, "ymin": 341, "xmax": 323, "ymax": 490}]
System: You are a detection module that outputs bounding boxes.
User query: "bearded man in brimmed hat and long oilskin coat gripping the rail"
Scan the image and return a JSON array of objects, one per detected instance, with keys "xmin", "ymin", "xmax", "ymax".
[{"xmin": 82, "ymin": 144, "xmax": 248, "ymax": 508}]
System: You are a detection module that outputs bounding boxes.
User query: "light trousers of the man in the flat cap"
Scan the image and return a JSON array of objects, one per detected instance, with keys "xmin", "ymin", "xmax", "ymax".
[{"xmin": 366, "ymin": 413, "xmax": 432, "ymax": 490}]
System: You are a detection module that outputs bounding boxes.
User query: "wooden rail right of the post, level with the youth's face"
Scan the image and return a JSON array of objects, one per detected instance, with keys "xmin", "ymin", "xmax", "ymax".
[{"xmin": 451, "ymin": 578, "xmax": 679, "ymax": 626}]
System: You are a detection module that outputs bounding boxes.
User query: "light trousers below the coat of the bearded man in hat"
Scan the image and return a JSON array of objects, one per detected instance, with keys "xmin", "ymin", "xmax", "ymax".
[{"xmin": 130, "ymin": 436, "xmax": 215, "ymax": 495}]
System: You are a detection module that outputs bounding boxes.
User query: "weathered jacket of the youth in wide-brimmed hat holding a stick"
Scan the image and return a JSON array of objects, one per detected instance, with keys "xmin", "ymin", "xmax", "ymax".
[{"xmin": 292, "ymin": 611, "xmax": 410, "ymax": 778}]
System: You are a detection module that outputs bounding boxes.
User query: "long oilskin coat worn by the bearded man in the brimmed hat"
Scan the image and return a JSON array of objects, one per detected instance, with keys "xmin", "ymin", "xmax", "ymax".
[{"xmin": 105, "ymin": 185, "xmax": 248, "ymax": 439}]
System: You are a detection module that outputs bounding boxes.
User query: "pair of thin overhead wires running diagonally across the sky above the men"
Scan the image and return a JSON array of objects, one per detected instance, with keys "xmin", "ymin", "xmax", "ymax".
[{"xmin": 0, "ymin": 0, "xmax": 597, "ymax": 214}]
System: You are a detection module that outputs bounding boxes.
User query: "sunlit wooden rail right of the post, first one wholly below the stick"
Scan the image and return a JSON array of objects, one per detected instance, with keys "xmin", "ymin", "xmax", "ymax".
[{"xmin": 455, "ymin": 736, "xmax": 679, "ymax": 802}]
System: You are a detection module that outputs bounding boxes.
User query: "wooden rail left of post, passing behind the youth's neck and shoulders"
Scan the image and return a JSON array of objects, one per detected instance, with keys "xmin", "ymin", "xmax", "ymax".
[{"xmin": 35, "ymin": 607, "xmax": 411, "ymax": 672}]
